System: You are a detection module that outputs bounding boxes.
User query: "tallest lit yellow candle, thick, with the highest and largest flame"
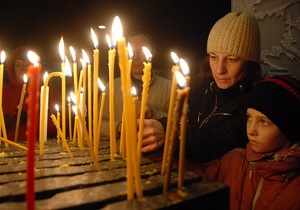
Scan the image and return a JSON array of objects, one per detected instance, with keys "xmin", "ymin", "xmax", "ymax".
[{"xmin": 113, "ymin": 16, "xmax": 143, "ymax": 200}]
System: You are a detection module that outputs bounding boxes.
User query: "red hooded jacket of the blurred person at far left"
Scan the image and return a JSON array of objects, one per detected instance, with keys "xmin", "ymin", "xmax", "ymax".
[{"xmin": 2, "ymin": 47, "xmax": 61, "ymax": 141}]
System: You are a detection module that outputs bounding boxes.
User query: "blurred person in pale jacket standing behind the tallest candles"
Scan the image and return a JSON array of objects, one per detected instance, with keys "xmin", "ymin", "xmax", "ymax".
[{"xmin": 101, "ymin": 31, "xmax": 172, "ymax": 138}]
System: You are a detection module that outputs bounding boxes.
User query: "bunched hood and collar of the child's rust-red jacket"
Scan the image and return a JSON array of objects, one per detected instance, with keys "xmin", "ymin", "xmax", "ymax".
[{"xmin": 246, "ymin": 143, "xmax": 300, "ymax": 181}]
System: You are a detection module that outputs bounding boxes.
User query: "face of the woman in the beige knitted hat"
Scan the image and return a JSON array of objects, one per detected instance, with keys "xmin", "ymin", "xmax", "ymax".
[{"xmin": 209, "ymin": 53, "xmax": 247, "ymax": 89}]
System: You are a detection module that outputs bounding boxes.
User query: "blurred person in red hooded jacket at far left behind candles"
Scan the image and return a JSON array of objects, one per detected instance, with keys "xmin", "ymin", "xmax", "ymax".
[{"xmin": 2, "ymin": 47, "xmax": 61, "ymax": 141}]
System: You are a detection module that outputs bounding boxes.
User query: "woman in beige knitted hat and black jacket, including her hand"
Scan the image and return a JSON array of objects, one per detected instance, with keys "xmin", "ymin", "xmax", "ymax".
[{"xmin": 142, "ymin": 12, "xmax": 264, "ymax": 162}]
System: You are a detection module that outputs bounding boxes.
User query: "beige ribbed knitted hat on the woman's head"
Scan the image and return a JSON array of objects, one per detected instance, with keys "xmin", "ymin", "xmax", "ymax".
[{"xmin": 207, "ymin": 12, "xmax": 260, "ymax": 62}]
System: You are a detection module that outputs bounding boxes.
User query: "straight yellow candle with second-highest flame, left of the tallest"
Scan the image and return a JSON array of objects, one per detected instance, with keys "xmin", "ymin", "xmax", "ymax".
[{"xmin": 91, "ymin": 28, "xmax": 99, "ymax": 151}]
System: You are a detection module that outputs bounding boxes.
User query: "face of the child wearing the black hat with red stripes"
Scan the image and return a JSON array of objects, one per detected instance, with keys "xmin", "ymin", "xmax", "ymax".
[{"xmin": 247, "ymin": 108, "xmax": 291, "ymax": 153}]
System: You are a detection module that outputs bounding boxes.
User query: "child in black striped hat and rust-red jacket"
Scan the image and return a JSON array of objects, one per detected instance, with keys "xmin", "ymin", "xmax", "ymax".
[{"xmin": 187, "ymin": 76, "xmax": 300, "ymax": 209}]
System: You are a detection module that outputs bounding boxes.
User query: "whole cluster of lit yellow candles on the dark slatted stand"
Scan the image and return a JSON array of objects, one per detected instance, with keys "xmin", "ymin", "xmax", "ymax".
[{"xmin": 0, "ymin": 17, "xmax": 190, "ymax": 205}]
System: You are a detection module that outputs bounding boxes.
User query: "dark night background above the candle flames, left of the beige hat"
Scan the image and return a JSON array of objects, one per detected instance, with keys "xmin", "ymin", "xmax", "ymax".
[{"xmin": 0, "ymin": 0, "xmax": 231, "ymax": 80}]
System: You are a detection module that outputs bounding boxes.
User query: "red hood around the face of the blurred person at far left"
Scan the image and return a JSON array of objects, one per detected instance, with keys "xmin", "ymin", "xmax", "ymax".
[{"xmin": 7, "ymin": 47, "xmax": 30, "ymax": 87}]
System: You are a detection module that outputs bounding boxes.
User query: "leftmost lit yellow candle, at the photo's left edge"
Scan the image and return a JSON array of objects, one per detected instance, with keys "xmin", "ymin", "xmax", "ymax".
[{"xmin": 0, "ymin": 50, "xmax": 8, "ymax": 147}]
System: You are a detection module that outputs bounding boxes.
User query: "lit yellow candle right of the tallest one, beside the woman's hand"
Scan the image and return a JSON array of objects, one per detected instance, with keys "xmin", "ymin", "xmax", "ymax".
[{"xmin": 137, "ymin": 47, "xmax": 152, "ymax": 163}]
